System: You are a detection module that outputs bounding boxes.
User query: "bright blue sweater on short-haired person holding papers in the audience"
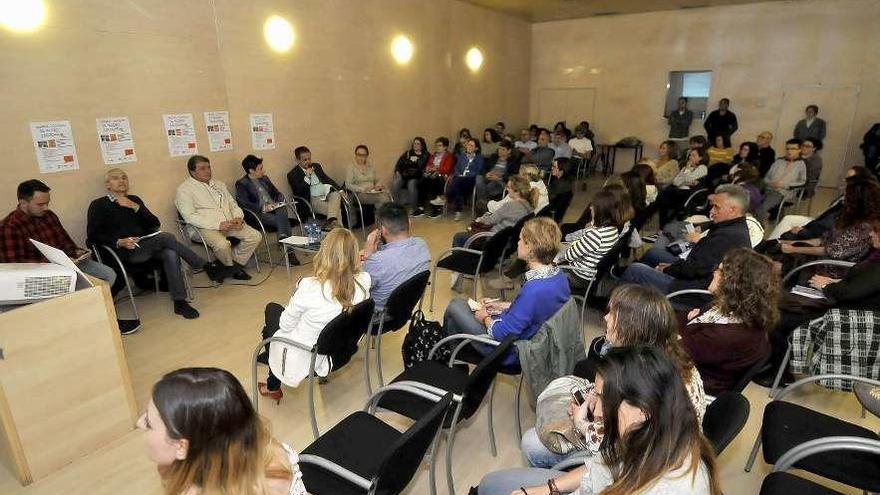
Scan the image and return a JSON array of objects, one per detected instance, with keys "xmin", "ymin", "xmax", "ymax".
[{"xmin": 489, "ymin": 267, "xmax": 571, "ymax": 365}]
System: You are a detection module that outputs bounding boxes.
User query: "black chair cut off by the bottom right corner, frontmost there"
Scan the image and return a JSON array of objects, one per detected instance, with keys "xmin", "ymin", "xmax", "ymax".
[{"xmin": 761, "ymin": 437, "xmax": 880, "ymax": 495}]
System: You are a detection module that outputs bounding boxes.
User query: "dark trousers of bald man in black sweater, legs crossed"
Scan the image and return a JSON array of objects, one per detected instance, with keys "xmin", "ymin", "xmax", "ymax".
[{"xmin": 116, "ymin": 232, "xmax": 206, "ymax": 301}]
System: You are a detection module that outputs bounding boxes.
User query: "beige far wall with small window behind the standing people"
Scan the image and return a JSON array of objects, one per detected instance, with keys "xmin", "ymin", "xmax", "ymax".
[{"xmin": 530, "ymin": 0, "xmax": 880, "ymax": 184}]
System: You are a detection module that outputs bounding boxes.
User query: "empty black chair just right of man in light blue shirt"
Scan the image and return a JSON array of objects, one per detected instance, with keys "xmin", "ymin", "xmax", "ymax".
[{"xmin": 431, "ymin": 227, "xmax": 514, "ymax": 312}]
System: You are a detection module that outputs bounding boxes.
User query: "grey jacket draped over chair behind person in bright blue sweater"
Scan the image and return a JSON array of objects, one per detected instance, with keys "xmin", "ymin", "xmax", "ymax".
[{"xmin": 514, "ymin": 299, "xmax": 587, "ymax": 409}]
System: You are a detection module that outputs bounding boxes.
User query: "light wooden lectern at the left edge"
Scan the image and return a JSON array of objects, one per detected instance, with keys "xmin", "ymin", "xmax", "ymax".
[{"xmin": 0, "ymin": 284, "xmax": 137, "ymax": 485}]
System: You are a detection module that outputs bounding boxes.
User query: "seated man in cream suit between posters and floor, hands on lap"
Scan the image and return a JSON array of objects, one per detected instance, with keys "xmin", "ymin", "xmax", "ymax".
[{"xmin": 174, "ymin": 155, "xmax": 263, "ymax": 280}]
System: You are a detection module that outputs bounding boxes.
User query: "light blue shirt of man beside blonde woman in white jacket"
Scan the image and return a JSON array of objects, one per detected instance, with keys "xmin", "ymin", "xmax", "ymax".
[{"xmin": 364, "ymin": 237, "xmax": 431, "ymax": 309}]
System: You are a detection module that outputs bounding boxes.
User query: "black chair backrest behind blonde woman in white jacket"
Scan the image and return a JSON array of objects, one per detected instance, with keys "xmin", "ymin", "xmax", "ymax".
[{"xmin": 315, "ymin": 298, "xmax": 375, "ymax": 370}]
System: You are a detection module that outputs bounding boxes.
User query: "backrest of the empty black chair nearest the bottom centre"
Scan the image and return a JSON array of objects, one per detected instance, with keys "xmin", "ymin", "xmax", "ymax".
[{"xmin": 373, "ymin": 393, "xmax": 452, "ymax": 495}]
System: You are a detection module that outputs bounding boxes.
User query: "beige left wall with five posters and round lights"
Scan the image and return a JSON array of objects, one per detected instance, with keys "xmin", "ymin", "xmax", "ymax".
[{"xmin": 0, "ymin": 0, "xmax": 531, "ymax": 241}]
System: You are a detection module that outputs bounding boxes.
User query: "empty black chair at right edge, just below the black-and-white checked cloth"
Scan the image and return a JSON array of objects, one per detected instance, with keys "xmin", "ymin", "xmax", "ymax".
[{"xmin": 745, "ymin": 374, "xmax": 880, "ymax": 492}]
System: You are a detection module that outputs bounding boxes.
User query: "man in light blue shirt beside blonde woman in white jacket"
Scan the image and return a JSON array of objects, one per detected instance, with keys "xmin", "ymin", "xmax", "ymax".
[{"xmin": 363, "ymin": 203, "xmax": 431, "ymax": 309}]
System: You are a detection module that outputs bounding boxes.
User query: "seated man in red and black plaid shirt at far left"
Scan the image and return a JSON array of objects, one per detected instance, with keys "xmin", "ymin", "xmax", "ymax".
[{"xmin": 0, "ymin": 179, "xmax": 140, "ymax": 335}]
